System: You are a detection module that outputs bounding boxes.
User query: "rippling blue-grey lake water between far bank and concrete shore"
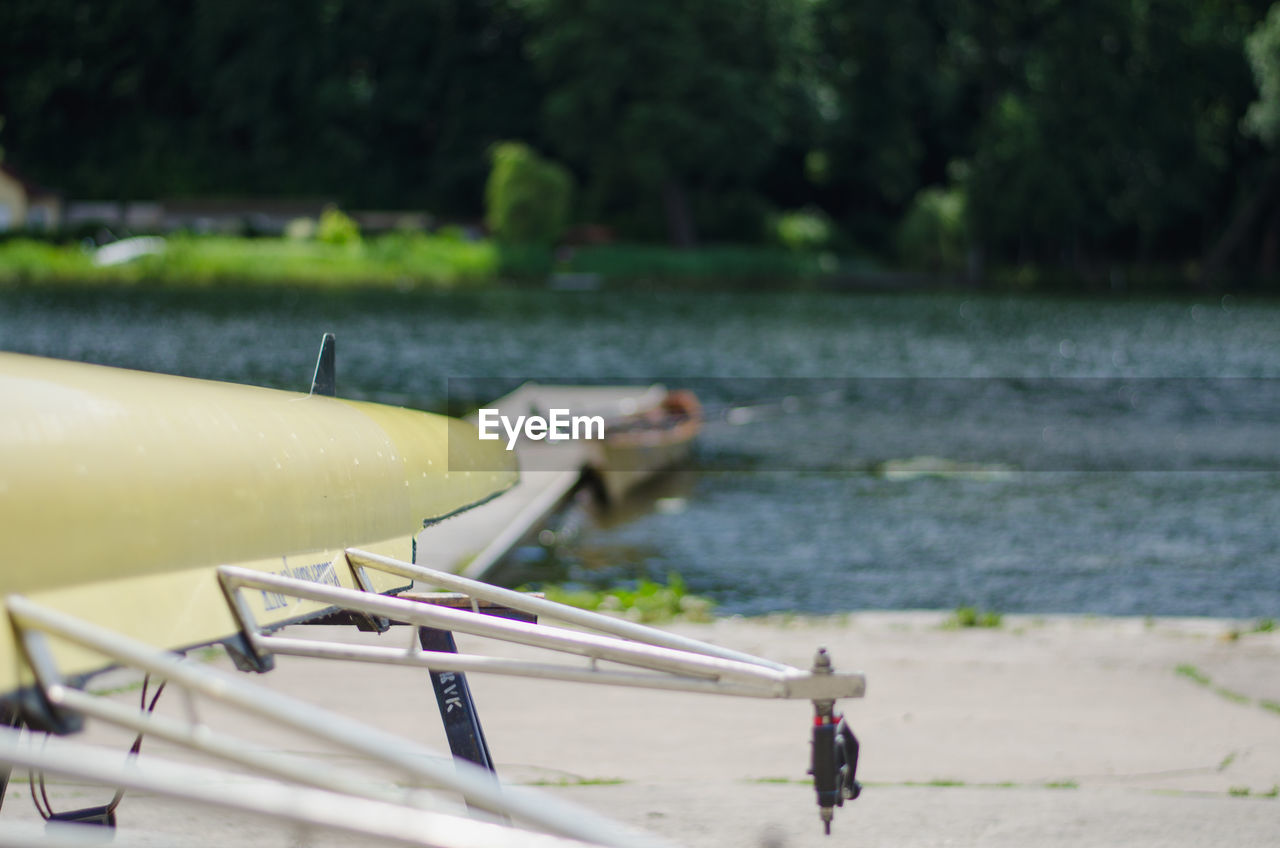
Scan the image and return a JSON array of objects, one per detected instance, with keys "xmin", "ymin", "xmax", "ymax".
[{"xmin": 0, "ymin": 288, "xmax": 1280, "ymax": 617}]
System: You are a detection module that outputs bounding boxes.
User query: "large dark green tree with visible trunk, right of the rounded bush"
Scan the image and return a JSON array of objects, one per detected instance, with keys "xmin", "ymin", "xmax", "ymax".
[{"xmin": 519, "ymin": 0, "xmax": 808, "ymax": 246}]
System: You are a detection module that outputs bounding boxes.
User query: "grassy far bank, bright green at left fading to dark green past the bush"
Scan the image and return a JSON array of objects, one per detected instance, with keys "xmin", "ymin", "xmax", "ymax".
[{"xmin": 0, "ymin": 233, "xmax": 836, "ymax": 288}]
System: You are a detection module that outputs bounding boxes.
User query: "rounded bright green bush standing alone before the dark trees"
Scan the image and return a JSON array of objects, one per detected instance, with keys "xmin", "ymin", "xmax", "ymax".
[{"xmin": 485, "ymin": 141, "xmax": 573, "ymax": 245}]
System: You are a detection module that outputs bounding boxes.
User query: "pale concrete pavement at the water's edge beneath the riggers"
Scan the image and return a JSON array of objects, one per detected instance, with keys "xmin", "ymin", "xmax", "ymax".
[{"xmin": 5, "ymin": 612, "xmax": 1280, "ymax": 848}]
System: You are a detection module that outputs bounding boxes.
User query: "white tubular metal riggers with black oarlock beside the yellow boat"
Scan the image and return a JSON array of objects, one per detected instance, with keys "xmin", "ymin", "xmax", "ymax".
[{"xmin": 0, "ymin": 548, "xmax": 865, "ymax": 848}]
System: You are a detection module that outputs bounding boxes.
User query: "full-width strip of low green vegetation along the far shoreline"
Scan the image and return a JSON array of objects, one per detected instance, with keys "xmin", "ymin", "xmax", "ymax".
[{"xmin": 0, "ymin": 234, "xmax": 1249, "ymax": 296}]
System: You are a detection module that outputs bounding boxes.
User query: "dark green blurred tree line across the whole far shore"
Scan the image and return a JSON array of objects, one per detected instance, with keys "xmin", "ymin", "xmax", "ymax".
[{"xmin": 0, "ymin": 0, "xmax": 1280, "ymax": 282}]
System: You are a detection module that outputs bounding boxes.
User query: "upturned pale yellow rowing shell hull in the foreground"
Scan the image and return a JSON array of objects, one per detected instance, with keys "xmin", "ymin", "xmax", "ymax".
[{"xmin": 0, "ymin": 354, "xmax": 517, "ymax": 697}]
